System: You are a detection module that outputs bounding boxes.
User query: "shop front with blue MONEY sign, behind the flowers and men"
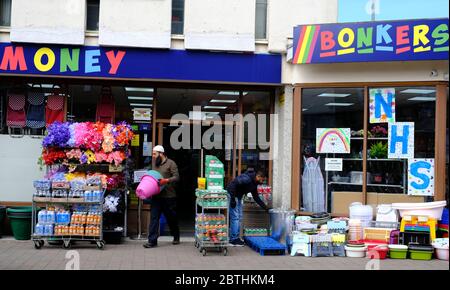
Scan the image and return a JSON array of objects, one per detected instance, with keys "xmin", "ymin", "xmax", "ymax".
[{"xmin": 0, "ymin": 43, "xmax": 281, "ymax": 235}]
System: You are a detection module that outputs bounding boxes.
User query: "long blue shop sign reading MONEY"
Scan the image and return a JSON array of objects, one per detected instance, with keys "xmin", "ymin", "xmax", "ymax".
[{"xmin": 0, "ymin": 43, "xmax": 281, "ymax": 85}]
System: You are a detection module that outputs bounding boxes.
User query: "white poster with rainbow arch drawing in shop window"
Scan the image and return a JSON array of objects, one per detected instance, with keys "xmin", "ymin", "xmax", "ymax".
[{"xmin": 316, "ymin": 128, "xmax": 350, "ymax": 153}]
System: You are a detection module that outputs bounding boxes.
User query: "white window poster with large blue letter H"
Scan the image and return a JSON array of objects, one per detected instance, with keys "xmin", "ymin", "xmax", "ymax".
[{"xmin": 388, "ymin": 122, "xmax": 414, "ymax": 159}]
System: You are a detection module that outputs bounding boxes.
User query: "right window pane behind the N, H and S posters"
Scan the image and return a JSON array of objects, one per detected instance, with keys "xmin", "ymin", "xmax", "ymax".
[{"xmin": 367, "ymin": 87, "xmax": 436, "ymax": 194}]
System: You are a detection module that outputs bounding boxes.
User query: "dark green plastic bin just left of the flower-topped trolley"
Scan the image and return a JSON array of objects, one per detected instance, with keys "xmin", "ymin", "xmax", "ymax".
[{"xmin": 6, "ymin": 206, "xmax": 32, "ymax": 240}]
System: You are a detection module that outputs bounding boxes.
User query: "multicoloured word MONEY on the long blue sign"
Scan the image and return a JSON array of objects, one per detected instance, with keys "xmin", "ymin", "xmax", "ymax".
[{"xmin": 0, "ymin": 44, "xmax": 126, "ymax": 75}]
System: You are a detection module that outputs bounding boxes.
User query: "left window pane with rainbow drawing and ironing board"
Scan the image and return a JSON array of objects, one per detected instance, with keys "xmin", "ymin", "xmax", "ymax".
[{"xmin": 301, "ymin": 88, "xmax": 364, "ymax": 212}]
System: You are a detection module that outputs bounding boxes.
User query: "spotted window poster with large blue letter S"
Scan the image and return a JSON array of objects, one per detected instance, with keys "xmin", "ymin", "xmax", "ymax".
[{"xmin": 408, "ymin": 159, "xmax": 434, "ymax": 196}]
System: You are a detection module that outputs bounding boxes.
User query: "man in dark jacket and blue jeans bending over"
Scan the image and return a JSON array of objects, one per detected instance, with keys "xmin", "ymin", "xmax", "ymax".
[{"xmin": 227, "ymin": 171, "xmax": 269, "ymax": 246}]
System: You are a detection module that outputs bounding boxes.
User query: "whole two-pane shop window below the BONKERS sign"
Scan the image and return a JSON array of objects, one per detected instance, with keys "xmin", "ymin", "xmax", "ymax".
[{"xmin": 301, "ymin": 86, "xmax": 440, "ymax": 214}]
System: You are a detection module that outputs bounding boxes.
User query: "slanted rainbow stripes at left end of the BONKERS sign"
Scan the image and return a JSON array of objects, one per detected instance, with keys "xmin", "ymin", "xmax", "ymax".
[{"xmin": 292, "ymin": 25, "xmax": 320, "ymax": 64}]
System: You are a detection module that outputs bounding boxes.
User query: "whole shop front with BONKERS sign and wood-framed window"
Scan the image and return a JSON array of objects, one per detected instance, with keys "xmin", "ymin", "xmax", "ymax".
[{"xmin": 285, "ymin": 19, "xmax": 448, "ymax": 216}]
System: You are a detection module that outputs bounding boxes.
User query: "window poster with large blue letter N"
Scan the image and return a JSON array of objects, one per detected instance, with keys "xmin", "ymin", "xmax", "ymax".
[{"xmin": 369, "ymin": 88, "xmax": 395, "ymax": 124}]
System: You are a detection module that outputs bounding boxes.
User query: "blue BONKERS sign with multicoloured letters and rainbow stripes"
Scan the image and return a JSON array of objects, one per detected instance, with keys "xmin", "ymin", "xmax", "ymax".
[{"xmin": 292, "ymin": 18, "xmax": 449, "ymax": 64}]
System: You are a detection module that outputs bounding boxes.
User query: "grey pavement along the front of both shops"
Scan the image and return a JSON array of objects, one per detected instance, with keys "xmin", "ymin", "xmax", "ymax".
[{"xmin": 0, "ymin": 237, "xmax": 449, "ymax": 270}]
